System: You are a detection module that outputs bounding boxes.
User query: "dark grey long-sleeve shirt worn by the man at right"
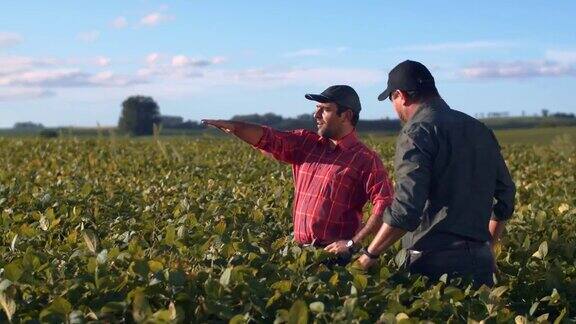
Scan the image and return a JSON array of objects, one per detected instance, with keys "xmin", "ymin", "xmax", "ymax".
[{"xmin": 384, "ymin": 98, "xmax": 516, "ymax": 250}]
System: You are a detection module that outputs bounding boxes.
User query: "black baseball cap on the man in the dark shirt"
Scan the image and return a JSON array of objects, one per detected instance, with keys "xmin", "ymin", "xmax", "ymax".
[{"xmin": 378, "ymin": 60, "xmax": 436, "ymax": 101}]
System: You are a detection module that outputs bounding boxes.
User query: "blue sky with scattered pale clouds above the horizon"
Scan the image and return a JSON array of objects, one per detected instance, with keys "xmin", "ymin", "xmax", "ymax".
[{"xmin": 0, "ymin": 0, "xmax": 576, "ymax": 127}]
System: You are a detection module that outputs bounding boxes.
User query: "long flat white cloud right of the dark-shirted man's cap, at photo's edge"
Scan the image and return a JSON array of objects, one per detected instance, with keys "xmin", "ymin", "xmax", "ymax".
[{"xmin": 460, "ymin": 60, "xmax": 576, "ymax": 79}]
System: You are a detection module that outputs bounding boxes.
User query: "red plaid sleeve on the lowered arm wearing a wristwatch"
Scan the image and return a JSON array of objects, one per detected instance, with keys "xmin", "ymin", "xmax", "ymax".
[{"xmin": 365, "ymin": 153, "xmax": 394, "ymax": 215}]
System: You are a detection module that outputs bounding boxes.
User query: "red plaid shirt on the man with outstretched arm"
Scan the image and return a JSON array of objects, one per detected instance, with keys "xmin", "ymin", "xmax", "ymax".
[{"xmin": 255, "ymin": 127, "xmax": 393, "ymax": 244}]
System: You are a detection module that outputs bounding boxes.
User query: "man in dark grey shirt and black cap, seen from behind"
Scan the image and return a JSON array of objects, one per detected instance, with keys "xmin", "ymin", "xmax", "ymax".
[{"xmin": 359, "ymin": 61, "xmax": 516, "ymax": 286}]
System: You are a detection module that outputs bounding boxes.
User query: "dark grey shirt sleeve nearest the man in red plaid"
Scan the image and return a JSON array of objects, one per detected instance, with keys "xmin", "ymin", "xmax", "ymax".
[{"xmin": 383, "ymin": 125, "xmax": 437, "ymax": 231}]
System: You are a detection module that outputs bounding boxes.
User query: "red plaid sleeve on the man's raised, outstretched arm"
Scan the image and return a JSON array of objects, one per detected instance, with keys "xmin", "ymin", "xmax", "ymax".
[{"xmin": 254, "ymin": 126, "xmax": 309, "ymax": 164}]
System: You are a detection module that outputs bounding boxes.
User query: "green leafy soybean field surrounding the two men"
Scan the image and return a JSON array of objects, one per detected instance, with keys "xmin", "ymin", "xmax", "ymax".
[{"xmin": 0, "ymin": 132, "xmax": 576, "ymax": 323}]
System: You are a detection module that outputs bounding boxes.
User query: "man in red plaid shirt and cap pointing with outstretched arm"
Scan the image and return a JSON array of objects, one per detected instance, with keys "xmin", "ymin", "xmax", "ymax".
[{"xmin": 203, "ymin": 85, "xmax": 393, "ymax": 264}]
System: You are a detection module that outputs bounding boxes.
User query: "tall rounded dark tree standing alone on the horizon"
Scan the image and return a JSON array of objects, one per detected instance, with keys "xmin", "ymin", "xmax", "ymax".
[{"xmin": 118, "ymin": 96, "xmax": 160, "ymax": 136}]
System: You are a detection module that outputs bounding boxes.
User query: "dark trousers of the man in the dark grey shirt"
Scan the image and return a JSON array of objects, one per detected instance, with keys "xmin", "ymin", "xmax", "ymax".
[{"xmin": 406, "ymin": 242, "xmax": 496, "ymax": 288}]
